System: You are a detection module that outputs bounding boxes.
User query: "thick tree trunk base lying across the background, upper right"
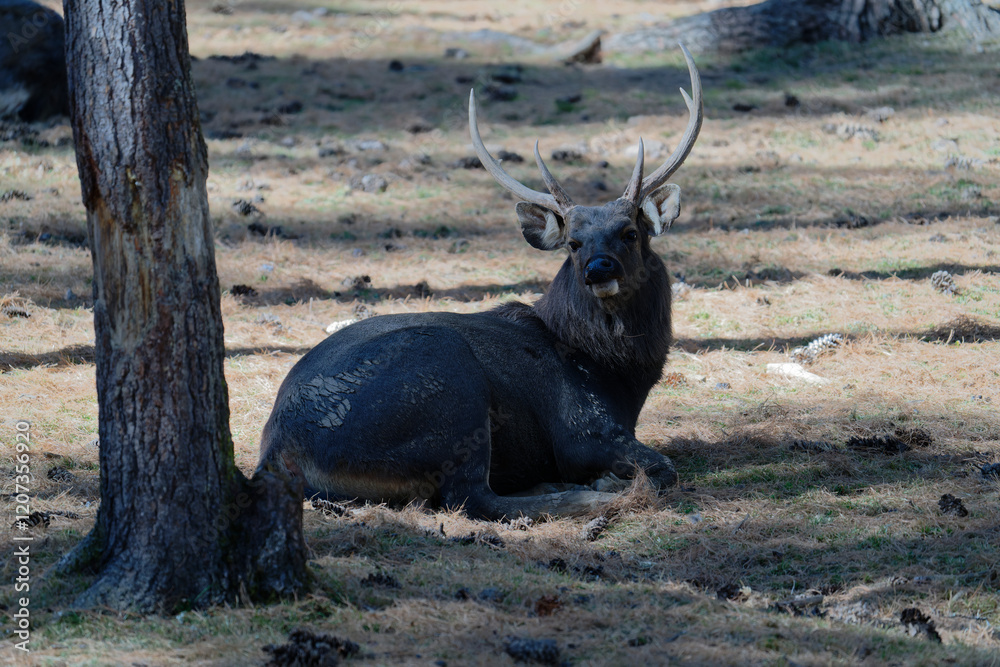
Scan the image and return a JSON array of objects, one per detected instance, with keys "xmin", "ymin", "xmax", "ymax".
[{"xmin": 604, "ymin": 0, "xmax": 1000, "ymax": 52}]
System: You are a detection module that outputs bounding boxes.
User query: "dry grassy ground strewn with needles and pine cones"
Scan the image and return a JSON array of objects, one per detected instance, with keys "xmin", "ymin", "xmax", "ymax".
[{"xmin": 0, "ymin": 1, "xmax": 1000, "ymax": 665}]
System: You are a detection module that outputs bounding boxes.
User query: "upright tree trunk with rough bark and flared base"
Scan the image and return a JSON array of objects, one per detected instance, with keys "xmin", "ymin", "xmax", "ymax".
[{"xmin": 63, "ymin": 0, "xmax": 306, "ymax": 611}]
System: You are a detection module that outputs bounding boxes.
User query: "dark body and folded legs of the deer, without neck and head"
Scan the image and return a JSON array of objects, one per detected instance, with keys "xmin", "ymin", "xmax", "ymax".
[{"xmin": 261, "ymin": 304, "xmax": 676, "ymax": 519}]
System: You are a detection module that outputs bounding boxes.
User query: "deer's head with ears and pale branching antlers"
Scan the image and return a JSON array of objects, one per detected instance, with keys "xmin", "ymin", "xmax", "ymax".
[{"xmin": 469, "ymin": 45, "xmax": 702, "ymax": 306}]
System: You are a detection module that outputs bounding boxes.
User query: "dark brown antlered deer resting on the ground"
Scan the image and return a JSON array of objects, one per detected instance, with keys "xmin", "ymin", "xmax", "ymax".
[{"xmin": 260, "ymin": 46, "xmax": 702, "ymax": 519}]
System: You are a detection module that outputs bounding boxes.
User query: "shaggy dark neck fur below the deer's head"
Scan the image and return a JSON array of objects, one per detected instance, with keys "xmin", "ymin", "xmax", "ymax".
[{"xmin": 534, "ymin": 248, "xmax": 671, "ymax": 382}]
